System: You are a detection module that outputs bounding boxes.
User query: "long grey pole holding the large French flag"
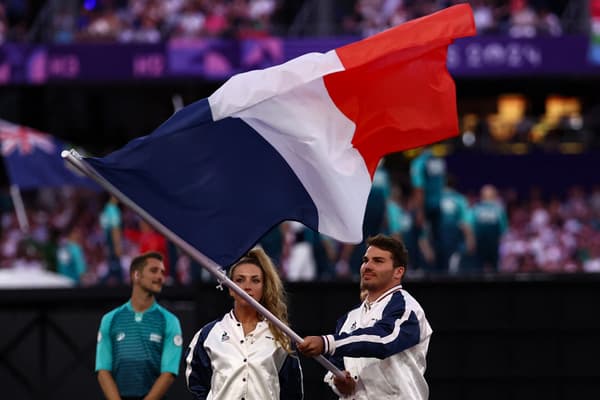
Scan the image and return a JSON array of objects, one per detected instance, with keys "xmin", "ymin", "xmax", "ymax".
[{"xmin": 61, "ymin": 150, "xmax": 344, "ymax": 378}]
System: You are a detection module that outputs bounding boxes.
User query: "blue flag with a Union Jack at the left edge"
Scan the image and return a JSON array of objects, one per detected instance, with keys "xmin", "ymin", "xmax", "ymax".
[{"xmin": 0, "ymin": 120, "xmax": 97, "ymax": 189}]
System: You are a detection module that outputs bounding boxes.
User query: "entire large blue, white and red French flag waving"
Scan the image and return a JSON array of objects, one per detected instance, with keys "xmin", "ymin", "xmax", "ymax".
[{"xmin": 86, "ymin": 4, "xmax": 475, "ymax": 266}]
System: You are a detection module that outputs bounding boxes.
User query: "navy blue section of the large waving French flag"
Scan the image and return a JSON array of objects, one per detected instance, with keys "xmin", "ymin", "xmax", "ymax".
[{"xmin": 86, "ymin": 99, "xmax": 318, "ymax": 266}]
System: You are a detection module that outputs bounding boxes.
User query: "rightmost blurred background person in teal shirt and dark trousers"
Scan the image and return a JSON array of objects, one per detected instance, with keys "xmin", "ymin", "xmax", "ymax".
[{"xmin": 472, "ymin": 185, "xmax": 508, "ymax": 272}]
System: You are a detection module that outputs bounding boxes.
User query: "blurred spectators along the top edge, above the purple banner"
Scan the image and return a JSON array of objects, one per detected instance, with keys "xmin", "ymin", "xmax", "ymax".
[{"xmin": 0, "ymin": 0, "xmax": 588, "ymax": 43}]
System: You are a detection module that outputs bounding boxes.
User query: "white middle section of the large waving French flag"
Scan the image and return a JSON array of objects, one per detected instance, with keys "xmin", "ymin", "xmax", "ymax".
[{"xmin": 209, "ymin": 52, "xmax": 371, "ymax": 243}]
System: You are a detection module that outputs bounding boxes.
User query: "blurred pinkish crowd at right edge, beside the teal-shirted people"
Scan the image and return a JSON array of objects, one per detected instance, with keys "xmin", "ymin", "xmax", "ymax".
[{"xmin": 500, "ymin": 186, "xmax": 600, "ymax": 273}]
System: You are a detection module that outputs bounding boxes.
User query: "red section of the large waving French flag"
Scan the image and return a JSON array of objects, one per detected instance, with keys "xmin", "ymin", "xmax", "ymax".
[{"xmin": 325, "ymin": 4, "xmax": 475, "ymax": 176}]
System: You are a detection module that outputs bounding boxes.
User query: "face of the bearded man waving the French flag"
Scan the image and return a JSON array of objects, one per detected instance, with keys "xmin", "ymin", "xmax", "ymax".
[{"xmin": 360, "ymin": 246, "xmax": 401, "ymax": 300}]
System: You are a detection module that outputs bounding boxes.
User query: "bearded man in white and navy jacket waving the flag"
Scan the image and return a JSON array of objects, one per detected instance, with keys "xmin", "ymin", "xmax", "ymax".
[{"xmin": 298, "ymin": 235, "xmax": 432, "ymax": 400}]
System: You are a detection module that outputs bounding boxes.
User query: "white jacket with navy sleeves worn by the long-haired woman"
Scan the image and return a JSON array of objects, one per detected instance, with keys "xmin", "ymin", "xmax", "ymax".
[{"xmin": 185, "ymin": 311, "xmax": 303, "ymax": 400}]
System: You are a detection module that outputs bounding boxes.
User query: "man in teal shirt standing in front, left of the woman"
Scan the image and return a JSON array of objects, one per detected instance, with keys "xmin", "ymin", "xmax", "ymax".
[{"xmin": 96, "ymin": 252, "xmax": 183, "ymax": 399}]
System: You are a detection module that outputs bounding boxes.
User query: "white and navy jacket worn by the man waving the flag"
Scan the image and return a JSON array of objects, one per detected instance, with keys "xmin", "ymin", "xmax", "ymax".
[{"xmin": 323, "ymin": 285, "xmax": 432, "ymax": 400}]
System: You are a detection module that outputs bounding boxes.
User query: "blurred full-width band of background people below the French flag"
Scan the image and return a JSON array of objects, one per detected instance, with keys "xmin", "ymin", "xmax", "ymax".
[{"xmin": 0, "ymin": 149, "xmax": 600, "ymax": 286}]
